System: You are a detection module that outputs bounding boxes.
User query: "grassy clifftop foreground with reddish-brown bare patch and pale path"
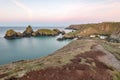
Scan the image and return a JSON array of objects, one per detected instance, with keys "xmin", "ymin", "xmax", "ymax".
[{"xmin": 0, "ymin": 39, "xmax": 120, "ymax": 80}]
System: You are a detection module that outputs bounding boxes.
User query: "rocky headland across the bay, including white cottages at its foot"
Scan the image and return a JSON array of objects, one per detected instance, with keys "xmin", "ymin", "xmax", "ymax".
[{"xmin": 62, "ymin": 22, "xmax": 120, "ymax": 42}]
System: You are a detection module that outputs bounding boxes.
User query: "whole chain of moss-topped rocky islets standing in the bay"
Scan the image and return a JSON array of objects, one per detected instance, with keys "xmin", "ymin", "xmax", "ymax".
[{"xmin": 4, "ymin": 25, "xmax": 65, "ymax": 39}]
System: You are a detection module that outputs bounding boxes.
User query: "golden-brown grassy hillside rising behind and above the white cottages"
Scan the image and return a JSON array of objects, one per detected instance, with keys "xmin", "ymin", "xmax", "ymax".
[{"xmin": 68, "ymin": 22, "xmax": 120, "ymax": 36}]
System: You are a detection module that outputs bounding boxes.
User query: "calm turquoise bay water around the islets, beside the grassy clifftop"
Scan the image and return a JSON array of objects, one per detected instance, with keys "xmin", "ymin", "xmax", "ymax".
[{"xmin": 0, "ymin": 28, "xmax": 70, "ymax": 65}]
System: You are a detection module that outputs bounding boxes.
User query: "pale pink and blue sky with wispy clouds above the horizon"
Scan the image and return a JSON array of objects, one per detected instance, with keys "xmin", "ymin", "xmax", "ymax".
[{"xmin": 0, "ymin": 0, "xmax": 120, "ymax": 26}]
